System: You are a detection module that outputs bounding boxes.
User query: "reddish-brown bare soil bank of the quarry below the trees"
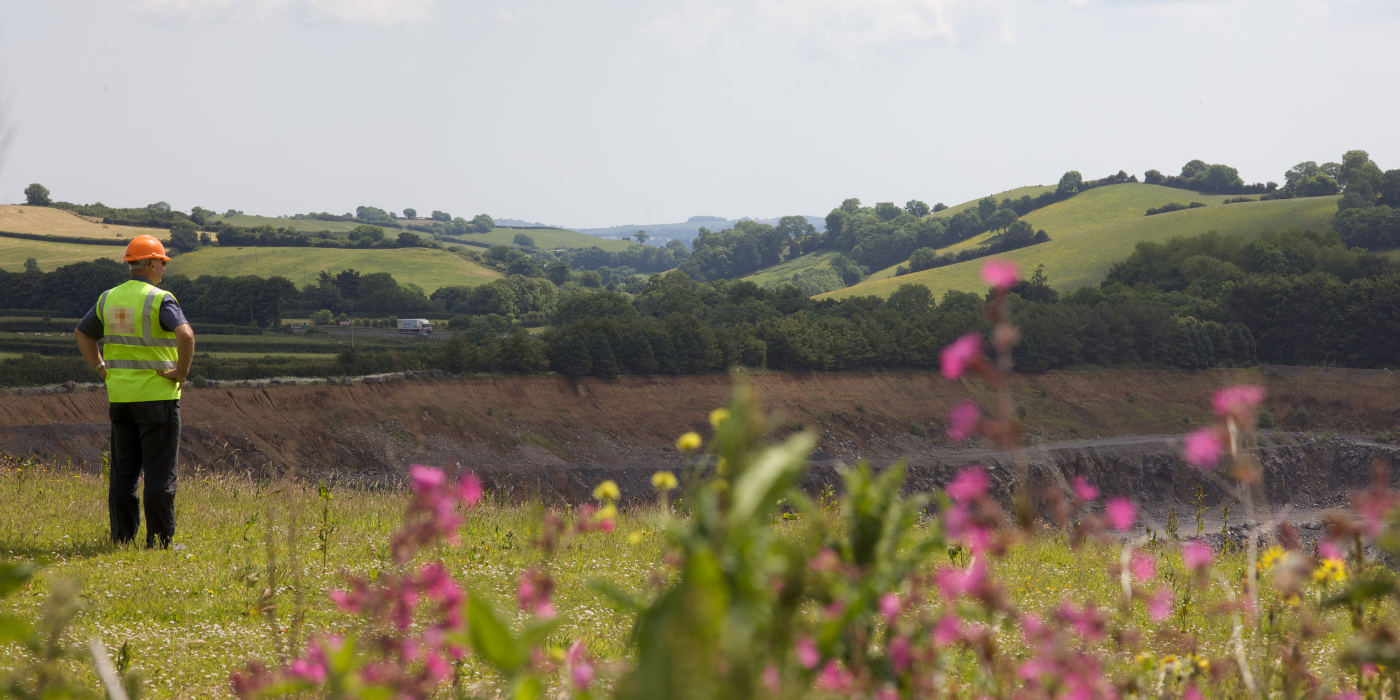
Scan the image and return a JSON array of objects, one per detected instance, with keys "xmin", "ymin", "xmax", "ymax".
[{"xmin": 0, "ymin": 367, "xmax": 1400, "ymax": 498}]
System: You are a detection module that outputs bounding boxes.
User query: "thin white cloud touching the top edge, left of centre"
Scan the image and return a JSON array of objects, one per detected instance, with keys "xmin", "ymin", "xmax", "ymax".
[{"xmin": 136, "ymin": 0, "xmax": 435, "ymax": 25}]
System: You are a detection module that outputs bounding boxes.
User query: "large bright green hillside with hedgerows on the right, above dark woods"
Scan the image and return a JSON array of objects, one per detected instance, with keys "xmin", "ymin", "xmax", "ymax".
[{"xmin": 822, "ymin": 183, "xmax": 1337, "ymax": 298}]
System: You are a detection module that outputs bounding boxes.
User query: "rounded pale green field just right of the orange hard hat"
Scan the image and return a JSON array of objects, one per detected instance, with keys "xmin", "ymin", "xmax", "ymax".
[{"xmin": 165, "ymin": 246, "xmax": 501, "ymax": 294}]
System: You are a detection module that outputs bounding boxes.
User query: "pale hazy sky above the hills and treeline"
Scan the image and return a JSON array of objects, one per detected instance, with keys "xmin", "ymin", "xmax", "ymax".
[{"xmin": 0, "ymin": 0, "xmax": 1400, "ymax": 227}]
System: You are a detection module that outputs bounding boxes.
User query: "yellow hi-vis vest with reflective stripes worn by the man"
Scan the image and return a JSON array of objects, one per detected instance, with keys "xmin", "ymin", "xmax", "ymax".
[{"xmin": 97, "ymin": 280, "xmax": 181, "ymax": 403}]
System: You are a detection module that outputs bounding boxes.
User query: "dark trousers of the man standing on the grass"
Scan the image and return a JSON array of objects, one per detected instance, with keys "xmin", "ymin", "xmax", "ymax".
[{"xmin": 106, "ymin": 399, "xmax": 179, "ymax": 547}]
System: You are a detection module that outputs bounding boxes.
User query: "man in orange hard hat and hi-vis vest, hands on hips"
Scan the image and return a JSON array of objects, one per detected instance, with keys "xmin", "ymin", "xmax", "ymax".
[{"xmin": 73, "ymin": 235, "xmax": 195, "ymax": 547}]
